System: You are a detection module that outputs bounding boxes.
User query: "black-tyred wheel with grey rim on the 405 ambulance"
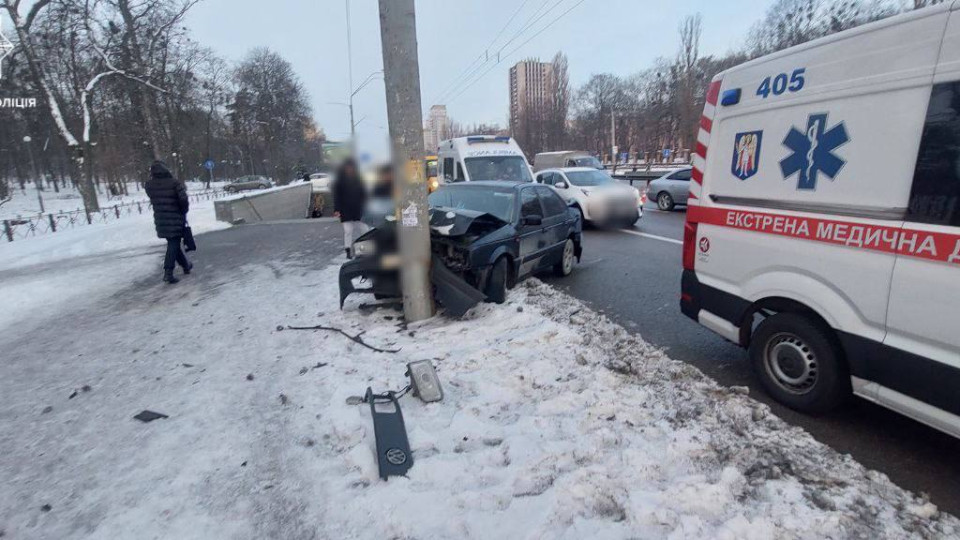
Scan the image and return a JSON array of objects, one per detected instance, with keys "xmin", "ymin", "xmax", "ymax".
[{"xmin": 749, "ymin": 313, "xmax": 850, "ymax": 413}]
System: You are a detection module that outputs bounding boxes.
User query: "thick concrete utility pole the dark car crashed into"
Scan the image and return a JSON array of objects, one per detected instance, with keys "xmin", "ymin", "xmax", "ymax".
[{"xmin": 379, "ymin": 0, "xmax": 434, "ymax": 322}]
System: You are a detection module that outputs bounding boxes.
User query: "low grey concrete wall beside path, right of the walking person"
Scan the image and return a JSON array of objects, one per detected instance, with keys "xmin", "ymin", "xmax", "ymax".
[{"xmin": 213, "ymin": 183, "xmax": 313, "ymax": 224}]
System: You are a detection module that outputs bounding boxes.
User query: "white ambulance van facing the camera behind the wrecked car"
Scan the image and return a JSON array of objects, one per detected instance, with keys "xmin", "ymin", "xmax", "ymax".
[{"xmin": 437, "ymin": 135, "xmax": 533, "ymax": 184}]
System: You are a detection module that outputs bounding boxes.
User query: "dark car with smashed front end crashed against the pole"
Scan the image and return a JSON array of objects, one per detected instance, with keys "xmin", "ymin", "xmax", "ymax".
[{"xmin": 340, "ymin": 181, "xmax": 583, "ymax": 316}]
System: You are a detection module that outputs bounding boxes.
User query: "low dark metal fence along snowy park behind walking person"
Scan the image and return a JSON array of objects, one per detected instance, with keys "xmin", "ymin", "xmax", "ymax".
[{"xmin": 3, "ymin": 189, "xmax": 229, "ymax": 242}]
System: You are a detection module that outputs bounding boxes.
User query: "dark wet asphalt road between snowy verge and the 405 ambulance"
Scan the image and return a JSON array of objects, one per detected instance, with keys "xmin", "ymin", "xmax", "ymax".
[{"xmin": 546, "ymin": 207, "xmax": 960, "ymax": 516}]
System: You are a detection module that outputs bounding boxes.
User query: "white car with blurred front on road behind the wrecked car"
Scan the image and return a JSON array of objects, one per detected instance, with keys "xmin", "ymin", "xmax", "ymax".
[{"xmin": 536, "ymin": 167, "xmax": 644, "ymax": 227}]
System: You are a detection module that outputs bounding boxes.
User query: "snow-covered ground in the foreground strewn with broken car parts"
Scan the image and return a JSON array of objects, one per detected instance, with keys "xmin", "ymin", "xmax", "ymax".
[{"xmin": 0, "ymin": 242, "xmax": 960, "ymax": 540}]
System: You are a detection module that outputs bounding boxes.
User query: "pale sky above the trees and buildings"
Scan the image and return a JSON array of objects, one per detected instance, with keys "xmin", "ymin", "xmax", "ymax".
[{"xmin": 186, "ymin": 0, "xmax": 772, "ymax": 158}]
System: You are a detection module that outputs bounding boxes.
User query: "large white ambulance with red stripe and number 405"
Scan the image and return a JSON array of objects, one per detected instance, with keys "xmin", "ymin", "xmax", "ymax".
[{"xmin": 680, "ymin": 2, "xmax": 960, "ymax": 436}]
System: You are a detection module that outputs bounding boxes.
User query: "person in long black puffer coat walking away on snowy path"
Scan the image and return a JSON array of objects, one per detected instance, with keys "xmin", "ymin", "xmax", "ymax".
[{"xmin": 144, "ymin": 161, "xmax": 193, "ymax": 284}]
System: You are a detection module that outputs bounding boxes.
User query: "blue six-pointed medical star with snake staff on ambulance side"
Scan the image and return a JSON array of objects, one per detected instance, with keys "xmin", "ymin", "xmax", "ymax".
[{"xmin": 780, "ymin": 113, "xmax": 850, "ymax": 190}]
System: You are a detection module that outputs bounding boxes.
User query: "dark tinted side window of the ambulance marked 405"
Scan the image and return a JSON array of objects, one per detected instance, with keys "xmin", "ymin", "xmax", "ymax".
[{"xmin": 906, "ymin": 82, "xmax": 960, "ymax": 227}]
